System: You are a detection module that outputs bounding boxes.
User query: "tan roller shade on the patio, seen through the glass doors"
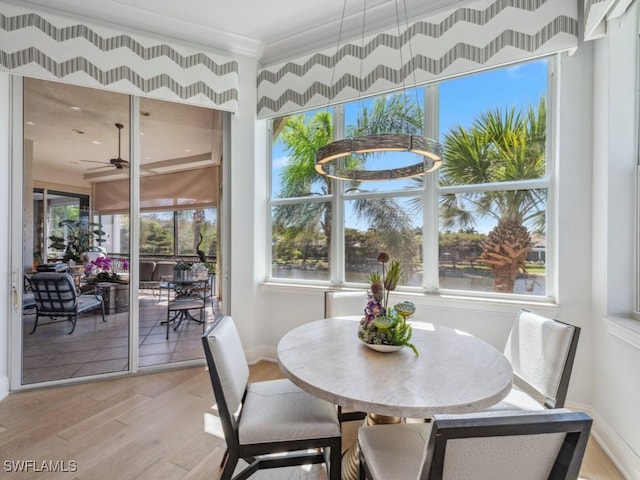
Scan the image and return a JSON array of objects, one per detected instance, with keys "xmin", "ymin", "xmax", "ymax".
[{"xmin": 92, "ymin": 167, "xmax": 218, "ymax": 214}]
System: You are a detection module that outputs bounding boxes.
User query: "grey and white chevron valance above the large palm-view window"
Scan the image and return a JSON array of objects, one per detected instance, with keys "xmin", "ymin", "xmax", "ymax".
[{"xmin": 257, "ymin": 0, "xmax": 578, "ymax": 118}]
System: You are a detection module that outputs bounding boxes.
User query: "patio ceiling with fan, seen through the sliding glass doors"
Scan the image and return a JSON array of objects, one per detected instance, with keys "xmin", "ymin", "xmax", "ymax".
[{"xmin": 24, "ymin": 78, "xmax": 222, "ymax": 186}]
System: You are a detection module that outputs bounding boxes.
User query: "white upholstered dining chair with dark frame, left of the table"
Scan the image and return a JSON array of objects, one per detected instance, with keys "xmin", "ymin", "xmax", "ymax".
[{"xmin": 202, "ymin": 316, "xmax": 342, "ymax": 480}]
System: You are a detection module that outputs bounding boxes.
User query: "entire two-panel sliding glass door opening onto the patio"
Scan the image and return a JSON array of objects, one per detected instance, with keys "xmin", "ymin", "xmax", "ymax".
[{"xmin": 13, "ymin": 78, "xmax": 222, "ymax": 385}]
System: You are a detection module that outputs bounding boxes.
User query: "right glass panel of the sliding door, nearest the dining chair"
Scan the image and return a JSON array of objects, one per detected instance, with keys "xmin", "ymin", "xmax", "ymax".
[{"xmin": 138, "ymin": 98, "xmax": 222, "ymax": 368}]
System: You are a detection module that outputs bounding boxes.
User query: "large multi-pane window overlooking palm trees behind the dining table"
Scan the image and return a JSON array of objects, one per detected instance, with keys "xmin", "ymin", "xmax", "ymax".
[{"xmin": 271, "ymin": 59, "xmax": 552, "ymax": 297}]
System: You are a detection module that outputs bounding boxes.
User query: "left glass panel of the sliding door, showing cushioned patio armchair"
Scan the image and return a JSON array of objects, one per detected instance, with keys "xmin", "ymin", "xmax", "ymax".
[{"xmin": 21, "ymin": 78, "xmax": 130, "ymax": 384}]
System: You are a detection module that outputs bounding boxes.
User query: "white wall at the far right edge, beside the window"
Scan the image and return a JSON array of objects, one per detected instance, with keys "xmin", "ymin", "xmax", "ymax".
[{"xmin": 591, "ymin": 2, "xmax": 640, "ymax": 478}]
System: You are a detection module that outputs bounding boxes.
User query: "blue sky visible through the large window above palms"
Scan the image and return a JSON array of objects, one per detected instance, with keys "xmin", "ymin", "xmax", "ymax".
[{"xmin": 272, "ymin": 59, "xmax": 547, "ymax": 230}]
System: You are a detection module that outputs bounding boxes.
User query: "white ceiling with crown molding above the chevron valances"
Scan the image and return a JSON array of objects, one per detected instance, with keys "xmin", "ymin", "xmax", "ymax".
[{"xmin": 20, "ymin": 0, "xmax": 469, "ymax": 65}]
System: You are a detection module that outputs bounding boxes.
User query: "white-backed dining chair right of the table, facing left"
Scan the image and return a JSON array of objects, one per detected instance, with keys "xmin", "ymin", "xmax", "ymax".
[{"xmin": 489, "ymin": 309, "xmax": 580, "ymax": 410}]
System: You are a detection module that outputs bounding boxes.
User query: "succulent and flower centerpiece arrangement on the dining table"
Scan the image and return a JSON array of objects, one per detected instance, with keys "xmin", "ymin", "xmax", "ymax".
[{"xmin": 358, "ymin": 252, "xmax": 418, "ymax": 355}]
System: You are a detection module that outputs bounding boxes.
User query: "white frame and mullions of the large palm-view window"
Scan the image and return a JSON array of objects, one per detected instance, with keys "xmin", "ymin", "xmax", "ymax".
[{"xmin": 265, "ymin": 54, "xmax": 556, "ymax": 304}]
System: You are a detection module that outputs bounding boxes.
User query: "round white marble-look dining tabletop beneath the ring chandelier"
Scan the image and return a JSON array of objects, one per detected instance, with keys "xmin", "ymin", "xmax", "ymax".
[{"xmin": 278, "ymin": 317, "xmax": 513, "ymax": 418}]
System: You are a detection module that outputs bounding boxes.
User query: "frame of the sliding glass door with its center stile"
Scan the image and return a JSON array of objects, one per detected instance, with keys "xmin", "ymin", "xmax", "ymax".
[{"xmin": 9, "ymin": 75, "xmax": 226, "ymax": 391}]
